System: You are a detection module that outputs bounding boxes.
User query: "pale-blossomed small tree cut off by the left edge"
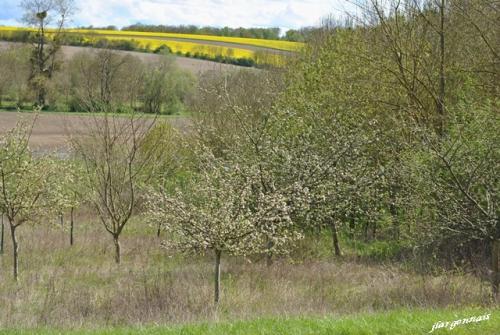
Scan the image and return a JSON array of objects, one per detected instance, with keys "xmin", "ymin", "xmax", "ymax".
[{"xmin": 0, "ymin": 119, "xmax": 58, "ymax": 281}]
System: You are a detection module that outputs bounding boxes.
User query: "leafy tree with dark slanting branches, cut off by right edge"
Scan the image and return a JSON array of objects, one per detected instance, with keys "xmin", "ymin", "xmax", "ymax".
[{"xmin": 407, "ymin": 105, "xmax": 500, "ymax": 296}]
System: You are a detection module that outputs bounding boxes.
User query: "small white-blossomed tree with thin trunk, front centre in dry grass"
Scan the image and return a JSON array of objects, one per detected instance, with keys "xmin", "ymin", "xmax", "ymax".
[{"xmin": 147, "ymin": 155, "xmax": 301, "ymax": 305}]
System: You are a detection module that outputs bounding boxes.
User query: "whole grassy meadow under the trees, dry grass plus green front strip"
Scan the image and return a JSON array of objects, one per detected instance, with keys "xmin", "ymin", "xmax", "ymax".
[{"xmin": 0, "ymin": 208, "xmax": 494, "ymax": 335}]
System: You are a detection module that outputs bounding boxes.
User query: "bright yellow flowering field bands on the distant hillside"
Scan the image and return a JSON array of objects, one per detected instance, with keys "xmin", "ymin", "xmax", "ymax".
[{"xmin": 0, "ymin": 27, "xmax": 304, "ymax": 66}]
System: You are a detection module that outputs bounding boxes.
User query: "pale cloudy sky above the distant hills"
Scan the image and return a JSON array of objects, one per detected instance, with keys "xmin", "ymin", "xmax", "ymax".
[{"xmin": 0, "ymin": 0, "xmax": 356, "ymax": 31}]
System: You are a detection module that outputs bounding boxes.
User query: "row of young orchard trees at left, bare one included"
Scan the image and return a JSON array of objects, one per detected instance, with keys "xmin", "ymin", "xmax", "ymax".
[{"xmin": 0, "ymin": 111, "xmax": 166, "ymax": 280}]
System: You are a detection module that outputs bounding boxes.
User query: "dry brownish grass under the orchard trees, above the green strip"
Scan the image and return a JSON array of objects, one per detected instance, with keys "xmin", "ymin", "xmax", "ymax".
[{"xmin": 0, "ymin": 210, "xmax": 489, "ymax": 328}]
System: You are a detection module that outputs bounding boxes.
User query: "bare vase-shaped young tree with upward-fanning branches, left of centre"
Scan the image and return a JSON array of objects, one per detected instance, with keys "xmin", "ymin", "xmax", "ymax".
[{"xmin": 71, "ymin": 113, "xmax": 157, "ymax": 264}]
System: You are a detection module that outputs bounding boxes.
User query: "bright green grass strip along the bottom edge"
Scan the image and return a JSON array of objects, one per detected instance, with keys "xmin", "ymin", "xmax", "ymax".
[{"xmin": 0, "ymin": 308, "xmax": 500, "ymax": 335}]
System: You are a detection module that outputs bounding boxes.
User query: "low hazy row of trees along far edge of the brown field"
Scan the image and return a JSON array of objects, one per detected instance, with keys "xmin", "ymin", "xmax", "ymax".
[{"xmin": 0, "ymin": 46, "xmax": 195, "ymax": 114}]
